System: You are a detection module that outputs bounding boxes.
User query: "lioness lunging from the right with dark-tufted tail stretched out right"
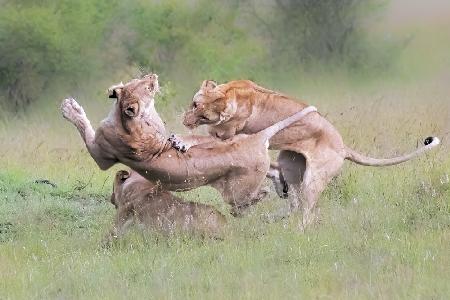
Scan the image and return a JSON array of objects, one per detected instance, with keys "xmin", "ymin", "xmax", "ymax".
[{"xmin": 180, "ymin": 80, "xmax": 439, "ymax": 228}]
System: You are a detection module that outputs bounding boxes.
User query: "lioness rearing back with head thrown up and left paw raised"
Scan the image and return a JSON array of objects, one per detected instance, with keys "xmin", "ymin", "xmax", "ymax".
[{"xmin": 61, "ymin": 74, "xmax": 316, "ymax": 216}]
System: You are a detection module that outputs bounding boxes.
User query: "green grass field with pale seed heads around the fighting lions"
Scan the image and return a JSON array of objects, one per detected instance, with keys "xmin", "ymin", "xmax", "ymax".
[{"xmin": 0, "ymin": 71, "xmax": 450, "ymax": 299}]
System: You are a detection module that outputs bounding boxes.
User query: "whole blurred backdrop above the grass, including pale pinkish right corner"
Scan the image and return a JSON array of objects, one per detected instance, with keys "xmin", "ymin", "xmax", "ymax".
[{"xmin": 0, "ymin": 0, "xmax": 450, "ymax": 113}]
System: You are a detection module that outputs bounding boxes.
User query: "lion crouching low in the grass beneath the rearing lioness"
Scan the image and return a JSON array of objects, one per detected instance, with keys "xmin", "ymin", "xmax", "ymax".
[{"xmin": 107, "ymin": 171, "xmax": 226, "ymax": 242}]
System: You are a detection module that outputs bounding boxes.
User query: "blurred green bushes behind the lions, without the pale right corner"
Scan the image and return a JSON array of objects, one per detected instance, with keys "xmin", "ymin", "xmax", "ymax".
[{"xmin": 0, "ymin": 0, "xmax": 391, "ymax": 111}]
